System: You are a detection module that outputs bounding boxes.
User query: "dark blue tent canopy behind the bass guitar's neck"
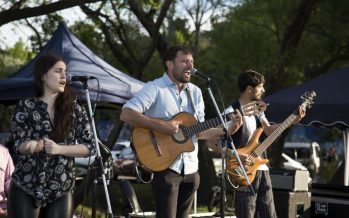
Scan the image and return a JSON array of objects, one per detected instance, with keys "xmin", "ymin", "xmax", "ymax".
[{"xmin": 264, "ymin": 68, "xmax": 349, "ymax": 130}]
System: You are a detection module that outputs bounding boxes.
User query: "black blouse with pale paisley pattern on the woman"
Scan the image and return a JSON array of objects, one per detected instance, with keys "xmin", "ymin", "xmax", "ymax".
[{"xmin": 11, "ymin": 98, "xmax": 95, "ymax": 207}]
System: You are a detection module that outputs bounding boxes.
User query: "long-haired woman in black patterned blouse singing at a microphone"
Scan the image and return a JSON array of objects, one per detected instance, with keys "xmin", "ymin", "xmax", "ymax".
[{"xmin": 8, "ymin": 54, "xmax": 95, "ymax": 218}]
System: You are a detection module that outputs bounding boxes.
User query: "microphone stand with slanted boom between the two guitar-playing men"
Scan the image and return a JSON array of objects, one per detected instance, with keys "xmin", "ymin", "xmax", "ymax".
[{"xmin": 205, "ymin": 78, "xmax": 255, "ymax": 218}]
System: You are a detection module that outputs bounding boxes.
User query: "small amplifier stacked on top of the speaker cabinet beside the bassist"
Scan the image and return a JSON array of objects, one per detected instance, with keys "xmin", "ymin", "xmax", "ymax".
[{"xmin": 270, "ymin": 170, "xmax": 309, "ymax": 192}]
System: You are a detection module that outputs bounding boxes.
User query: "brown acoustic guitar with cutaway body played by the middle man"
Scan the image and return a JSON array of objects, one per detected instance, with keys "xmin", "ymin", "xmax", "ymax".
[{"xmin": 132, "ymin": 102, "xmax": 258, "ymax": 172}]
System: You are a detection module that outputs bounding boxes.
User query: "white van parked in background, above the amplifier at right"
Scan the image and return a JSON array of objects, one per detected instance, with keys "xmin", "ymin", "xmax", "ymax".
[{"xmin": 283, "ymin": 142, "xmax": 321, "ymax": 173}]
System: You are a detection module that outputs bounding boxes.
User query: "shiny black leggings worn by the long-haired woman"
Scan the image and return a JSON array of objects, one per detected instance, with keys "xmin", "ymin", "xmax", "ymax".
[{"xmin": 7, "ymin": 183, "xmax": 73, "ymax": 218}]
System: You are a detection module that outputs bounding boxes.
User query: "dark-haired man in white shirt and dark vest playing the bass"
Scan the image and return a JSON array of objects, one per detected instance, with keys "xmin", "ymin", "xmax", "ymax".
[{"xmin": 227, "ymin": 70, "xmax": 305, "ymax": 218}]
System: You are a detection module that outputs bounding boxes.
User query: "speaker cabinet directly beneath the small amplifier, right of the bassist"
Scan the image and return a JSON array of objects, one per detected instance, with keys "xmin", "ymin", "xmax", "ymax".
[{"xmin": 273, "ymin": 189, "xmax": 311, "ymax": 218}]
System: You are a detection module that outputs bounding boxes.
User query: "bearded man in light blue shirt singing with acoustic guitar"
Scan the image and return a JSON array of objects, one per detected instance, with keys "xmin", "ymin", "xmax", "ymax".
[{"xmin": 120, "ymin": 46, "xmax": 241, "ymax": 218}]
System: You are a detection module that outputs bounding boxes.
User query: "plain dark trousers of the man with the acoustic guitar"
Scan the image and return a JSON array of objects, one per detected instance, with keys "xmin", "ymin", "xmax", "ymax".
[{"xmin": 152, "ymin": 170, "xmax": 200, "ymax": 218}]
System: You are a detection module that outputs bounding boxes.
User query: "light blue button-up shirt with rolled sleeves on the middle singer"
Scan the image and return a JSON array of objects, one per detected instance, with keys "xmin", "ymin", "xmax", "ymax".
[{"xmin": 123, "ymin": 73, "xmax": 205, "ymax": 174}]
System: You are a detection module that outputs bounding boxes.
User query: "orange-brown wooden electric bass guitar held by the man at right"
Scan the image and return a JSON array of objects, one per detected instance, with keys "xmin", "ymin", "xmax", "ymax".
[{"xmin": 226, "ymin": 91, "xmax": 316, "ymax": 186}]
